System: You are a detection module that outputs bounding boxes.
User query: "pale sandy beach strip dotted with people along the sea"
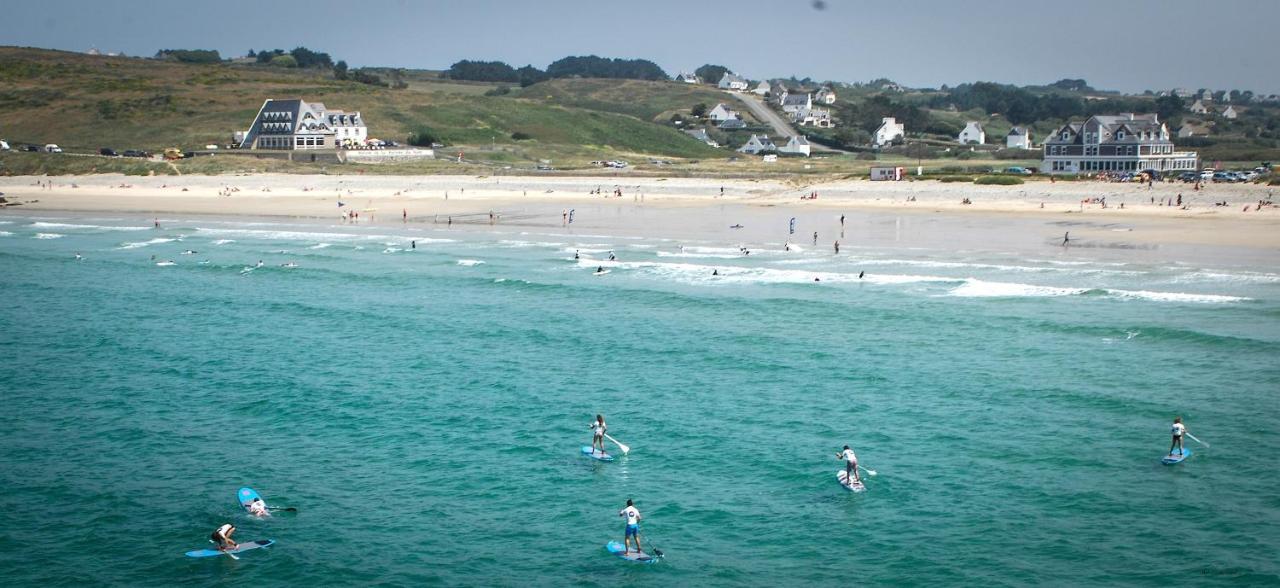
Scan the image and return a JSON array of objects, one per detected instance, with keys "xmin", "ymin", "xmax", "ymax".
[{"xmin": 0, "ymin": 174, "xmax": 1280, "ymax": 254}]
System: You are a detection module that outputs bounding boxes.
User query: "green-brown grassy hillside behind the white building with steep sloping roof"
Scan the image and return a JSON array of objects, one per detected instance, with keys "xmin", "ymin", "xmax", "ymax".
[{"xmin": 0, "ymin": 47, "xmax": 723, "ymax": 165}]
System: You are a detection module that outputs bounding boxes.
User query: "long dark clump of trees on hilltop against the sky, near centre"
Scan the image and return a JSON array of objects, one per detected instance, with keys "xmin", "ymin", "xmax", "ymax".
[{"xmin": 444, "ymin": 55, "xmax": 668, "ymax": 87}]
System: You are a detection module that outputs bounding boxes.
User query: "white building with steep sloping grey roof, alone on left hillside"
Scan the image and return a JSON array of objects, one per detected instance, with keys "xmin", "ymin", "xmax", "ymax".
[{"xmin": 239, "ymin": 99, "xmax": 369, "ymax": 150}]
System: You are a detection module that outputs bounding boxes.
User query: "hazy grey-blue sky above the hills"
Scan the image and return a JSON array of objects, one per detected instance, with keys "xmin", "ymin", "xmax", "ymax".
[{"xmin": 0, "ymin": 0, "xmax": 1280, "ymax": 94}]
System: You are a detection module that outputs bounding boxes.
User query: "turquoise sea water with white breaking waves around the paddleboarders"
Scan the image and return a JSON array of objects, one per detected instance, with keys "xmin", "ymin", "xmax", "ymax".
[{"xmin": 0, "ymin": 215, "xmax": 1280, "ymax": 585}]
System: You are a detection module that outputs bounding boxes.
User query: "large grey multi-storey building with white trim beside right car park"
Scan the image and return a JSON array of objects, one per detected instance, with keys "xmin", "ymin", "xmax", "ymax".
[{"xmin": 1041, "ymin": 113, "xmax": 1199, "ymax": 173}]
